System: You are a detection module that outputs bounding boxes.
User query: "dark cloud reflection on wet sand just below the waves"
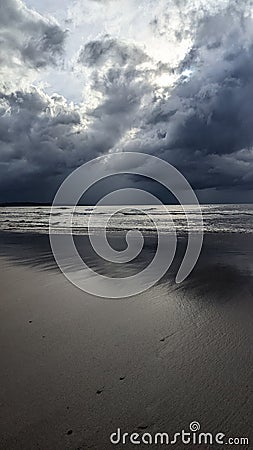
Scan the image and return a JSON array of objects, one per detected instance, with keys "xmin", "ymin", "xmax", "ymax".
[{"xmin": 0, "ymin": 232, "xmax": 253, "ymax": 302}]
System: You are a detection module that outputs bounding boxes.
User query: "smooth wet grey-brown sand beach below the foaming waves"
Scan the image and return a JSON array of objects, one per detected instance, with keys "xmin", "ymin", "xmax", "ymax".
[{"xmin": 0, "ymin": 233, "xmax": 253, "ymax": 450}]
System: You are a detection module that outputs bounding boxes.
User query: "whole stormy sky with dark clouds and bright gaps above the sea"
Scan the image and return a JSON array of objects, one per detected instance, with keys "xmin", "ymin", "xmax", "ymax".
[{"xmin": 0, "ymin": 0, "xmax": 253, "ymax": 203}]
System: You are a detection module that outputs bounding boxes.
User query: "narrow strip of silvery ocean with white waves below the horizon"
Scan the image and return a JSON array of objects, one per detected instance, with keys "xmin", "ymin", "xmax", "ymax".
[{"xmin": 0, "ymin": 204, "xmax": 253, "ymax": 234}]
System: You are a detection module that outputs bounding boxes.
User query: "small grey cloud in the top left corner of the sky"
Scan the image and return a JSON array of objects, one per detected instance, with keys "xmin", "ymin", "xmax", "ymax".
[{"xmin": 0, "ymin": 0, "xmax": 66, "ymax": 68}]
